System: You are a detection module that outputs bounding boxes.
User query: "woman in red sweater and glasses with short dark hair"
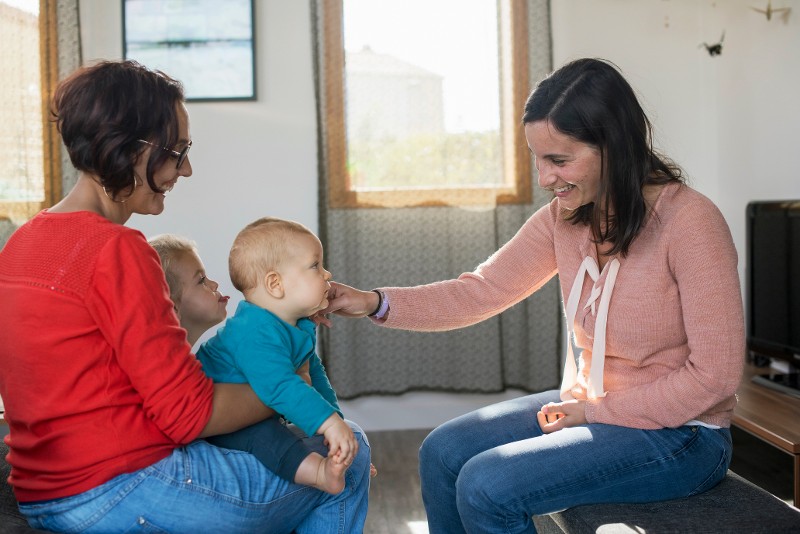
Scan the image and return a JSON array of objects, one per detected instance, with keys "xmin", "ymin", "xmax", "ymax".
[{"xmin": 0, "ymin": 61, "xmax": 369, "ymax": 532}]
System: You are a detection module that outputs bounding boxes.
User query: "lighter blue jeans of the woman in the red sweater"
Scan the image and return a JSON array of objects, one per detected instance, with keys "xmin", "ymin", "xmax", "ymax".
[{"xmin": 20, "ymin": 421, "xmax": 370, "ymax": 534}]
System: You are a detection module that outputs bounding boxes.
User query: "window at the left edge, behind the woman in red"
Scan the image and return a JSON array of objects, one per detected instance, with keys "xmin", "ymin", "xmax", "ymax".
[{"xmin": 0, "ymin": 0, "xmax": 61, "ymax": 225}]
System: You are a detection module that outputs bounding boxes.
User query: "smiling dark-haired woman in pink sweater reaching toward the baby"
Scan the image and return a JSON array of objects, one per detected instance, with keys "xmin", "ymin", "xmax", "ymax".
[{"xmin": 325, "ymin": 59, "xmax": 745, "ymax": 534}]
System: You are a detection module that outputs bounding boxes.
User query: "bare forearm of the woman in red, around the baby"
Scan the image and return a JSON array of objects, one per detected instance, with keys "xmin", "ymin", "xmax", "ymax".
[{"xmin": 198, "ymin": 384, "xmax": 275, "ymax": 438}]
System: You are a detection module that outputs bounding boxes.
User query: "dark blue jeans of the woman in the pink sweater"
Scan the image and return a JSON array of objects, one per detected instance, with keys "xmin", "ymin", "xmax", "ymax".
[{"xmin": 419, "ymin": 391, "xmax": 732, "ymax": 534}]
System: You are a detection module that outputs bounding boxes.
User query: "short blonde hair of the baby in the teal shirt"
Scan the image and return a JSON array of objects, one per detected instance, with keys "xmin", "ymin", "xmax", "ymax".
[{"xmin": 228, "ymin": 217, "xmax": 314, "ymax": 293}]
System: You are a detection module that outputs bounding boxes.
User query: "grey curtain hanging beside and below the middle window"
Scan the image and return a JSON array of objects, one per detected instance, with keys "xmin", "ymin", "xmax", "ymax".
[{"xmin": 312, "ymin": 0, "xmax": 563, "ymax": 398}]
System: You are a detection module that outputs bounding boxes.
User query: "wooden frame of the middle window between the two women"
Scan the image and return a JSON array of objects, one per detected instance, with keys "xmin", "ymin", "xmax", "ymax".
[{"xmin": 322, "ymin": 0, "xmax": 532, "ymax": 208}]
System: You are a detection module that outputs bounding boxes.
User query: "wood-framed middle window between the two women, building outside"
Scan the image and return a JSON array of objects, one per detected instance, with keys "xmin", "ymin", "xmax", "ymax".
[{"xmin": 322, "ymin": 0, "xmax": 531, "ymax": 208}]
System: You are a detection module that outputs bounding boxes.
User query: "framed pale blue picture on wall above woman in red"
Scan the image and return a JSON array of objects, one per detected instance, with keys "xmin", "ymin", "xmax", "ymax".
[{"xmin": 122, "ymin": 0, "xmax": 256, "ymax": 101}]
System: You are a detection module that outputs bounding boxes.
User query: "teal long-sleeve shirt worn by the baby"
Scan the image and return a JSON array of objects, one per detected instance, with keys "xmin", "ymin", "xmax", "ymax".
[{"xmin": 197, "ymin": 301, "xmax": 342, "ymax": 436}]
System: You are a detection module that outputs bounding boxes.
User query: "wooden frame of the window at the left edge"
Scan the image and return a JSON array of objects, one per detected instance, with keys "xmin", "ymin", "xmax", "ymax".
[{"xmin": 0, "ymin": 0, "xmax": 62, "ymax": 221}]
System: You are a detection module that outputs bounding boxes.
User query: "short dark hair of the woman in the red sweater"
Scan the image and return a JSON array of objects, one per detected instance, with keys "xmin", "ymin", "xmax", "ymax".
[{"xmin": 51, "ymin": 61, "xmax": 184, "ymax": 198}]
